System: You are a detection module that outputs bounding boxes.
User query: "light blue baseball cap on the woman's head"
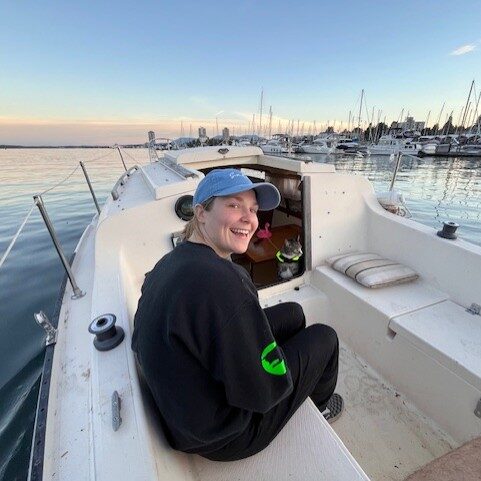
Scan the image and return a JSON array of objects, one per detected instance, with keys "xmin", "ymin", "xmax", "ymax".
[{"xmin": 193, "ymin": 169, "xmax": 281, "ymax": 210}]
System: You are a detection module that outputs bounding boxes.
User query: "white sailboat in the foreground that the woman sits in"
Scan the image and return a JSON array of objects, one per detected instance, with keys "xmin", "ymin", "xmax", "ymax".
[{"xmin": 29, "ymin": 146, "xmax": 481, "ymax": 481}]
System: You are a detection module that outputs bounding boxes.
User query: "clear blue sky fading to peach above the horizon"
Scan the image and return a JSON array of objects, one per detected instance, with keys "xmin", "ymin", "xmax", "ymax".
[{"xmin": 0, "ymin": 0, "xmax": 481, "ymax": 145}]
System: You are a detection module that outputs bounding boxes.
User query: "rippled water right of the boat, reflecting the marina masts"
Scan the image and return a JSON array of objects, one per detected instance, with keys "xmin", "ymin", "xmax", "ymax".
[{"xmin": 296, "ymin": 154, "xmax": 481, "ymax": 245}]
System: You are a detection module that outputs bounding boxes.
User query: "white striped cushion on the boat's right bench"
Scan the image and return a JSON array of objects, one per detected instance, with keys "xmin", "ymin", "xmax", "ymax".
[{"xmin": 326, "ymin": 252, "xmax": 419, "ymax": 289}]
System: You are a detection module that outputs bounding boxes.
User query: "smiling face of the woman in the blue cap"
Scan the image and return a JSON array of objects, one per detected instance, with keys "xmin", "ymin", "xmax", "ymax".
[{"xmin": 197, "ymin": 190, "xmax": 259, "ymax": 257}]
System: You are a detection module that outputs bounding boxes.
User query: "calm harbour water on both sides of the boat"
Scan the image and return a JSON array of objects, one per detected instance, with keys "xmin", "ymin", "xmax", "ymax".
[{"xmin": 0, "ymin": 149, "xmax": 481, "ymax": 481}]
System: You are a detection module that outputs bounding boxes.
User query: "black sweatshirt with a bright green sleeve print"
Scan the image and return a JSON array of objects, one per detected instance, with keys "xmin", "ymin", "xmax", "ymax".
[{"xmin": 132, "ymin": 242, "xmax": 292, "ymax": 454}]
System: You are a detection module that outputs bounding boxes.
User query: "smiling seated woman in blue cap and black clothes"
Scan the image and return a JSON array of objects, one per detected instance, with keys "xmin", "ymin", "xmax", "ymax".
[{"xmin": 132, "ymin": 169, "xmax": 342, "ymax": 461}]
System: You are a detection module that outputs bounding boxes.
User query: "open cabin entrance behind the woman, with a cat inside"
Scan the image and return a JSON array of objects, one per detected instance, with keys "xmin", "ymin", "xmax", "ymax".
[{"xmin": 196, "ymin": 165, "xmax": 305, "ymax": 289}]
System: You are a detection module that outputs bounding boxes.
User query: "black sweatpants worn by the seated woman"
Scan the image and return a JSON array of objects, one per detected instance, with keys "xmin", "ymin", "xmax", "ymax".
[{"xmin": 202, "ymin": 302, "xmax": 339, "ymax": 461}]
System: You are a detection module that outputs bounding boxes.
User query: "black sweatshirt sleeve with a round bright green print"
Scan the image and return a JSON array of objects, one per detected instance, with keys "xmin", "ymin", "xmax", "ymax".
[{"xmin": 212, "ymin": 299, "xmax": 292, "ymax": 413}]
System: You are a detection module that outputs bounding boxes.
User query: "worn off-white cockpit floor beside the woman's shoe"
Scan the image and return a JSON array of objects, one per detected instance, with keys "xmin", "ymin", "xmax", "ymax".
[{"xmin": 332, "ymin": 345, "xmax": 459, "ymax": 481}]
